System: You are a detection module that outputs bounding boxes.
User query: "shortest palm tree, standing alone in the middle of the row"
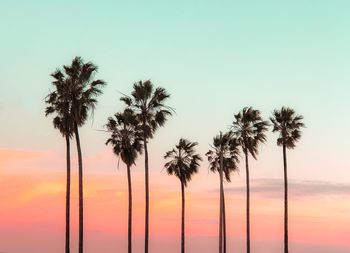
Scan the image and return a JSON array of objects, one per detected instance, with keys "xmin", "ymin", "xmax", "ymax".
[{"xmin": 164, "ymin": 139, "xmax": 202, "ymax": 253}]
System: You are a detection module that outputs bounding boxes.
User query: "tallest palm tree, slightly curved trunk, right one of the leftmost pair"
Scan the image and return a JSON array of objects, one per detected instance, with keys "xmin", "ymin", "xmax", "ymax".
[{"xmin": 64, "ymin": 57, "xmax": 106, "ymax": 253}]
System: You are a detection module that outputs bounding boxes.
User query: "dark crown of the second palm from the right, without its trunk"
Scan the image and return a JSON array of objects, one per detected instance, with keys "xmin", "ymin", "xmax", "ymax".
[{"xmin": 232, "ymin": 107, "xmax": 269, "ymax": 158}]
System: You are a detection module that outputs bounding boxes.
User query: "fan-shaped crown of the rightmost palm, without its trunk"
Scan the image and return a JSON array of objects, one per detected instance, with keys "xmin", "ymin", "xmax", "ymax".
[{"xmin": 270, "ymin": 107, "xmax": 305, "ymax": 149}]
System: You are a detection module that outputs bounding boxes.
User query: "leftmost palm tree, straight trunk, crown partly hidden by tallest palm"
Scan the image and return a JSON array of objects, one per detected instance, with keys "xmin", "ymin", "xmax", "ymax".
[{"xmin": 45, "ymin": 70, "xmax": 73, "ymax": 253}]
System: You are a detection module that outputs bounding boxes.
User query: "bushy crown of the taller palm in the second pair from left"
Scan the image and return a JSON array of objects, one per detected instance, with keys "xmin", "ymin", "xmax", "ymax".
[{"xmin": 121, "ymin": 80, "xmax": 172, "ymax": 139}]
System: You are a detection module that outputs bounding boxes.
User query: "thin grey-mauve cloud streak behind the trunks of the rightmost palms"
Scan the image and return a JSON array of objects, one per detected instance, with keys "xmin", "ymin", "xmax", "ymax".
[{"xmin": 225, "ymin": 178, "xmax": 350, "ymax": 198}]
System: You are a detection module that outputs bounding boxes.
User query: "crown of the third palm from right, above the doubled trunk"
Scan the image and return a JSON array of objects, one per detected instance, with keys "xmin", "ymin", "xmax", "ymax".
[{"xmin": 206, "ymin": 132, "xmax": 239, "ymax": 182}]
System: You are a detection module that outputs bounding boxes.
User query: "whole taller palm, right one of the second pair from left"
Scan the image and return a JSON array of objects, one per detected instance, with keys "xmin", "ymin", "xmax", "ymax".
[{"xmin": 121, "ymin": 80, "xmax": 172, "ymax": 253}]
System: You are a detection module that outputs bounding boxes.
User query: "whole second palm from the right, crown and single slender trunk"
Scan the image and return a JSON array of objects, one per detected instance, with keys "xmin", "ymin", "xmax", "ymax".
[{"xmin": 232, "ymin": 107, "xmax": 269, "ymax": 253}]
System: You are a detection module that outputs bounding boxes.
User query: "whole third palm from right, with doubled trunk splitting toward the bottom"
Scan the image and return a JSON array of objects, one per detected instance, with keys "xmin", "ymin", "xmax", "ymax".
[{"xmin": 206, "ymin": 132, "xmax": 239, "ymax": 253}]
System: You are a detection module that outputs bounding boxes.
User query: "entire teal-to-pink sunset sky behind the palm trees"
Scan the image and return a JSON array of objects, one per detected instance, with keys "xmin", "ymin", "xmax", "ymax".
[{"xmin": 0, "ymin": 0, "xmax": 350, "ymax": 253}]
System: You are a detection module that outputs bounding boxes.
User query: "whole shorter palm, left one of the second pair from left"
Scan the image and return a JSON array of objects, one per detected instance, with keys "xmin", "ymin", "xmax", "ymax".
[{"xmin": 106, "ymin": 109, "xmax": 142, "ymax": 253}]
